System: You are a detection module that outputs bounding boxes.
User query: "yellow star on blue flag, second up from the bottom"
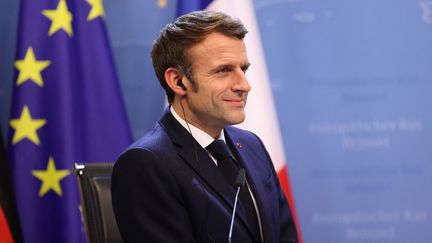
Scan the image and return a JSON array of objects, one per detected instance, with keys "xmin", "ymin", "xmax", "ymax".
[{"xmin": 9, "ymin": 106, "xmax": 46, "ymax": 145}]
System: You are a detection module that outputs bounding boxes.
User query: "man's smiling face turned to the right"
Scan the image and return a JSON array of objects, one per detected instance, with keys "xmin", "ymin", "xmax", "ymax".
[{"xmin": 183, "ymin": 32, "xmax": 250, "ymax": 132}]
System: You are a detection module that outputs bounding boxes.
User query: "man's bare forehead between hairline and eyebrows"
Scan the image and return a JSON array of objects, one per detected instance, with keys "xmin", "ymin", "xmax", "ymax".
[{"xmin": 188, "ymin": 32, "xmax": 248, "ymax": 66}]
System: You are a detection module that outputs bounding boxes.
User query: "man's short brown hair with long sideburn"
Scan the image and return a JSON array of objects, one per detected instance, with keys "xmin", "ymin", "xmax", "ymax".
[{"xmin": 151, "ymin": 11, "xmax": 247, "ymax": 103}]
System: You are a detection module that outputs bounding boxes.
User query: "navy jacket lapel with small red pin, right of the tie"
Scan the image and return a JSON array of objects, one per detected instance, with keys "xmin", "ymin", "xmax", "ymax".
[{"xmin": 225, "ymin": 129, "xmax": 273, "ymax": 242}]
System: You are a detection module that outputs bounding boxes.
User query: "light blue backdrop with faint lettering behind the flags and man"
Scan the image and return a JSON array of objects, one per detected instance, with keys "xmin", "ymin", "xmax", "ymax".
[{"xmin": 0, "ymin": 0, "xmax": 432, "ymax": 243}]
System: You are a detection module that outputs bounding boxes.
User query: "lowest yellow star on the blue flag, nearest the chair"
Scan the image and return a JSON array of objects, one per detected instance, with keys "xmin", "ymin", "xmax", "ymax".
[{"xmin": 32, "ymin": 156, "xmax": 70, "ymax": 197}]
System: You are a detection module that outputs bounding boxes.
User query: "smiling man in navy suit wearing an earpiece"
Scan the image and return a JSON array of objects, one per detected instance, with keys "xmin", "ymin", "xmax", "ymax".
[{"xmin": 112, "ymin": 11, "xmax": 297, "ymax": 242}]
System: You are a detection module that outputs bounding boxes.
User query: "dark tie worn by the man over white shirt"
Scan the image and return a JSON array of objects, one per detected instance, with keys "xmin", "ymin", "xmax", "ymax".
[{"xmin": 206, "ymin": 139, "xmax": 261, "ymax": 242}]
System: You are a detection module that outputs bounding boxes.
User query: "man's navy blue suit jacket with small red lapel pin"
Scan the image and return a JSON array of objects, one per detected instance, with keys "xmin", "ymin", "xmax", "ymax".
[{"xmin": 111, "ymin": 110, "xmax": 297, "ymax": 243}]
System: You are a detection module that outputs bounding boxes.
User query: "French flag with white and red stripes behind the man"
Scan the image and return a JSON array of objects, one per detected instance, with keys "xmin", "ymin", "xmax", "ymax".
[{"xmin": 177, "ymin": 0, "xmax": 302, "ymax": 242}]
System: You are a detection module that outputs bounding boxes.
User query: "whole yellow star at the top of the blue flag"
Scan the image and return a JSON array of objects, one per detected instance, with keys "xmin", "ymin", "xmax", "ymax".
[{"xmin": 42, "ymin": 0, "xmax": 73, "ymax": 36}]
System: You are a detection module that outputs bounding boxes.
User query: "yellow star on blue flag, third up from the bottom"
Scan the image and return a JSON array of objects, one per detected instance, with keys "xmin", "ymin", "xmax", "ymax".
[{"xmin": 15, "ymin": 47, "xmax": 51, "ymax": 87}]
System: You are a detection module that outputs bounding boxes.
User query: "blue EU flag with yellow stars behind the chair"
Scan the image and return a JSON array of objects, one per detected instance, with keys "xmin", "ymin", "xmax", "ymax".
[{"xmin": 9, "ymin": 0, "xmax": 132, "ymax": 243}]
